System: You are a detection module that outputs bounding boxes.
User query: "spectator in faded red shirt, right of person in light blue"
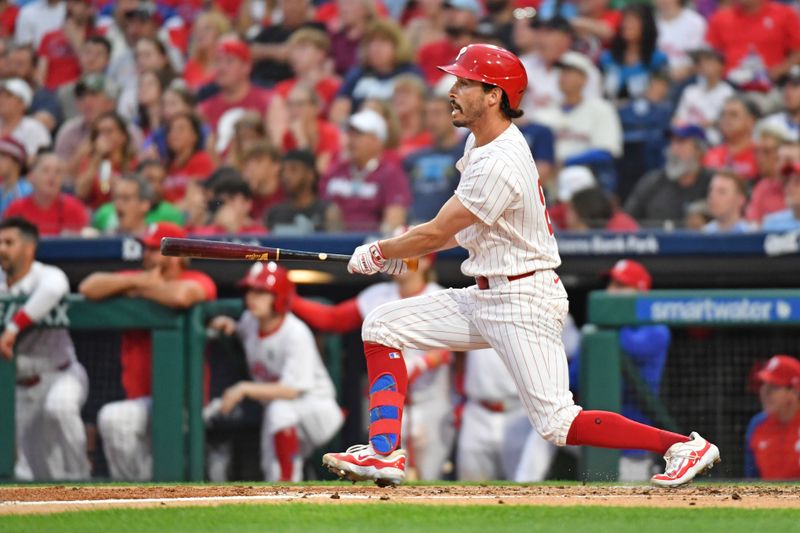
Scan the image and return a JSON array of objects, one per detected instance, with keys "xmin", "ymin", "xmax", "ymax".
[{"xmin": 745, "ymin": 129, "xmax": 787, "ymax": 224}]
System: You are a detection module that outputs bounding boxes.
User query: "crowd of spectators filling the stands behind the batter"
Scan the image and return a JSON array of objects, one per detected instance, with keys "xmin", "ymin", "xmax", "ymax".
[{"xmin": 0, "ymin": 0, "xmax": 800, "ymax": 236}]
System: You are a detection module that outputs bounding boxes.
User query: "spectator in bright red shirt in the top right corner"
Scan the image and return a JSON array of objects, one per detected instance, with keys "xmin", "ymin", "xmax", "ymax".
[{"xmin": 706, "ymin": 0, "xmax": 800, "ymax": 82}]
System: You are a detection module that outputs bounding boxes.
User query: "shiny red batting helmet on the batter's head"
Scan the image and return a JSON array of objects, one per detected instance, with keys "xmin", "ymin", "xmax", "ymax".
[{"xmin": 438, "ymin": 44, "xmax": 528, "ymax": 109}]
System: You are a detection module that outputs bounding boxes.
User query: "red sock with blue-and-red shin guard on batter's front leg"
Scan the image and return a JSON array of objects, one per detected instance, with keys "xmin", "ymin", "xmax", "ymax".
[{"xmin": 364, "ymin": 342, "xmax": 408, "ymax": 454}]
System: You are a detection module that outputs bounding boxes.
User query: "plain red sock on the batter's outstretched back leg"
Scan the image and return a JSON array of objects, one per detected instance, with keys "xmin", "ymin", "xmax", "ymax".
[{"xmin": 567, "ymin": 411, "xmax": 689, "ymax": 455}]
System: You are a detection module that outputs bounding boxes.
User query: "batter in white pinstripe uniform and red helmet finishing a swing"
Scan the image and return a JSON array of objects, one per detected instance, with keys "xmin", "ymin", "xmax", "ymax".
[{"xmin": 323, "ymin": 44, "xmax": 719, "ymax": 486}]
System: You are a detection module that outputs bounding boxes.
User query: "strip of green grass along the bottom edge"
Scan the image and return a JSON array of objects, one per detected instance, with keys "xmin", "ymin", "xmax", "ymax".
[{"xmin": 0, "ymin": 503, "xmax": 800, "ymax": 533}]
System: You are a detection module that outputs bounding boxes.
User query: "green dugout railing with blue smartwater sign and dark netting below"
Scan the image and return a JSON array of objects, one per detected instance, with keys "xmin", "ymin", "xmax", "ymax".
[{"xmin": 579, "ymin": 290, "xmax": 800, "ymax": 481}]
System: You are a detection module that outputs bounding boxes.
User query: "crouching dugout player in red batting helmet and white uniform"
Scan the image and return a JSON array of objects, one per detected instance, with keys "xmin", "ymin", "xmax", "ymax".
[{"xmin": 206, "ymin": 263, "xmax": 343, "ymax": 481}]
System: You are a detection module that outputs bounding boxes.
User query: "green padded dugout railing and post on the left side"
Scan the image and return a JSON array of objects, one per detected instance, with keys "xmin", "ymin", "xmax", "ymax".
[{"xmin": 0, "ymin": 294, "xmax": 342, "ymax": 482}]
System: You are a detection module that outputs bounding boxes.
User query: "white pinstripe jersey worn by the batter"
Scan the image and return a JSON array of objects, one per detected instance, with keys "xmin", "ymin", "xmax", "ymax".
[{"xmin": 455, "ymin": 124, "xmax": 561, "ymax": 276}]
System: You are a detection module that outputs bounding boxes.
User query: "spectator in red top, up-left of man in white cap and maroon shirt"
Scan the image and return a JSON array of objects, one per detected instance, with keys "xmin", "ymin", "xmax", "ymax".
[{"xmin": 283, "ymin": 85, "xmax": 341, "ymax": 174}]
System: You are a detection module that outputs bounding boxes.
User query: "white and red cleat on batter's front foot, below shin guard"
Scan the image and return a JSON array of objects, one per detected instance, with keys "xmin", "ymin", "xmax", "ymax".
[{"xmin": 322, "ymin": 444, "xmax": 408, "ymax": 487}]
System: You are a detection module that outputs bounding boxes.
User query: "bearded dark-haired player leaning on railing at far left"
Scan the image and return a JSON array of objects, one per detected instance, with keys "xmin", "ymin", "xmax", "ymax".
[{"xmin": 0, "ymin": 218, "xmax": 91, "ymax": 481}]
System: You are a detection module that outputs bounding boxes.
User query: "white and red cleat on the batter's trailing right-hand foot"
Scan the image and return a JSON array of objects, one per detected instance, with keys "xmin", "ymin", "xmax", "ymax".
[{"xmin": 650, "ymin": 431, "xmax": 721, "ymax": 487}]
